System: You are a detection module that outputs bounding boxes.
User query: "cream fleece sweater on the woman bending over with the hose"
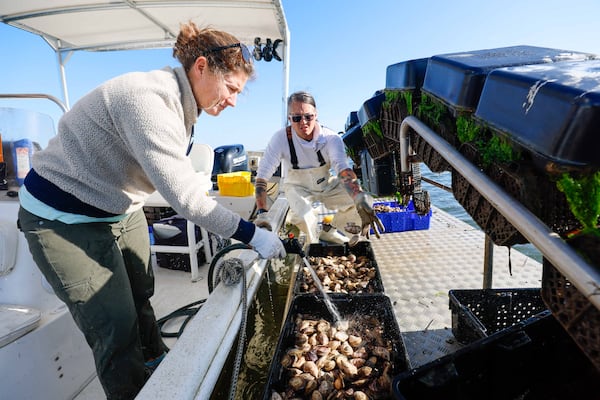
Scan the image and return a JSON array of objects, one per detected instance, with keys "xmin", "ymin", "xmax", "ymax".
[{"xmin": 32, "ymin": 67, "xmax": 240, "ymax": 237}]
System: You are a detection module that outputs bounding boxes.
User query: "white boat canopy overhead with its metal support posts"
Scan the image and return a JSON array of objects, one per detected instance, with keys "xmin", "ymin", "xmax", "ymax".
[{"xmin": 0, "ymin": 0, "xmax": 289, "ymax": 113}]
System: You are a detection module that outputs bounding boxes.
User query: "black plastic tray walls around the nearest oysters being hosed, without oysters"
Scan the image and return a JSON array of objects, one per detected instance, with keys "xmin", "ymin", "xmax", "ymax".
[{"xmin": 263, "ymin": 295, "xmax": 408, "ymax": 400}]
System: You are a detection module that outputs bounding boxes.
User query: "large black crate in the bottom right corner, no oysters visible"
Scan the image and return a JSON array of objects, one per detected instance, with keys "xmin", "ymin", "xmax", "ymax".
[{"xmin": 393, "ymin": 311, "xmax": 600, "ymax": 400}]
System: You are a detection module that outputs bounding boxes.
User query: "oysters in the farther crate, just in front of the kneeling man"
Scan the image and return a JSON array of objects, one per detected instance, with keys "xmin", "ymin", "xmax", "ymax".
[{"xmin": 299, "ymin": 253, "xmax": 377, "ymax": 294}]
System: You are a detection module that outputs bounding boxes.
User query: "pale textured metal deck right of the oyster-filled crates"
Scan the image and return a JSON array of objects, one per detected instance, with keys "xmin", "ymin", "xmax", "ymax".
[{"xmin": 371, "ymin": 207, "xmax": 542, "ymax": 368}]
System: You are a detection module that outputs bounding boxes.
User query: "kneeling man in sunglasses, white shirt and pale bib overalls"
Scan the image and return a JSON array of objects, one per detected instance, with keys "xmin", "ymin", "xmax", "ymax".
[{"xmin": 256, "ymin": 92, "xmax": 384, "ymax": 243}]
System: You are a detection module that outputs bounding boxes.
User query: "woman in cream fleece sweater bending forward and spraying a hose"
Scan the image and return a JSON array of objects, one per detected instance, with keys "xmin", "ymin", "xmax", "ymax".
[{"xmin": 19, "ymin": 22, "xmax": 285, "ymax": 399}]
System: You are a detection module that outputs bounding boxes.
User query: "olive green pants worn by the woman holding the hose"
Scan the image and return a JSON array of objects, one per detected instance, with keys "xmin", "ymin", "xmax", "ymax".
[{"xmin": 18, "ymin": 208, "xmax": 168, "ymax": 400}]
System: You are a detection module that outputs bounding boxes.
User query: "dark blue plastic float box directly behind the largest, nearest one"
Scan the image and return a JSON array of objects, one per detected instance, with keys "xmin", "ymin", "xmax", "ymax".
[{"xmin": 423, "ymin": 46, "xmax": 591, "ymax": 112}]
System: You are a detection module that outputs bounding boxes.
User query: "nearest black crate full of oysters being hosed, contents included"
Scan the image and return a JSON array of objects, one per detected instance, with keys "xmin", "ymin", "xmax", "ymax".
[{"xmin": 263, "ymin": 294, "xmax": 409, "ymax": 400}]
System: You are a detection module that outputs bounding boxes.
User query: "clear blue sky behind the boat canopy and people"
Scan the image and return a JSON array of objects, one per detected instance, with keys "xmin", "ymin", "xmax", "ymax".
[{"xmin": 0, "ymin": 0, "xmax": 600, "ymax": 150}]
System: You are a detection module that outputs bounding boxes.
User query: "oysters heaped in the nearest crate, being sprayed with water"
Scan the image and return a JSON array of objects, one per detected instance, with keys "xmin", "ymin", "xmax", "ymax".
[{"xmin": 271, "ymin": 315, "xmax": 393, "ymax": 400}]
